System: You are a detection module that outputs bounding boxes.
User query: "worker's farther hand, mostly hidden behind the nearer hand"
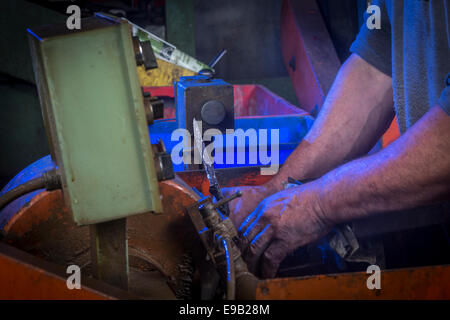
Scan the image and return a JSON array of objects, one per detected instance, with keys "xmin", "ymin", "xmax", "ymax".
[{"xmin": 222, "ymin": 185, "xmax": 274, "ymax": 230}]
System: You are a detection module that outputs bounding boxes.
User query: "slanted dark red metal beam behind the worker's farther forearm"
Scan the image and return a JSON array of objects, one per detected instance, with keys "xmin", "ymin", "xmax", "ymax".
[{"xmin": 280, "ymin": 0, "xmax": 341, "ymax": 111}]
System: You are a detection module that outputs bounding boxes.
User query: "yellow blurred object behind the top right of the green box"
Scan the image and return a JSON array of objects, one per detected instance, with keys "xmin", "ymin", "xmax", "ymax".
[{"xmin": 137, "ymin": 58, "xmax": 196, "ymax": 87}]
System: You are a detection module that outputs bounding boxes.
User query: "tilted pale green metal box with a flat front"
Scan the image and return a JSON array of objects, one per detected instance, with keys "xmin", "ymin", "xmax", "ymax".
[{"xmin": 29, "ymin": 18, "xmax": 161, "ymax": 225}]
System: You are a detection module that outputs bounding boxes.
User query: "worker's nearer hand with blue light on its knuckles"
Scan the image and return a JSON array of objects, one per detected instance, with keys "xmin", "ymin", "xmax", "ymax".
[{"xmin": 239, "ymin": 182, "xmax": 333, "ymax": 278}]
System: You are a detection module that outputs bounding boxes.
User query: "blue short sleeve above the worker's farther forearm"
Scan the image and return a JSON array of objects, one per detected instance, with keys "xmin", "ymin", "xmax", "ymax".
[{"xmin": 350, "ymin": 0, "xmax": 392, "ymax": 76}]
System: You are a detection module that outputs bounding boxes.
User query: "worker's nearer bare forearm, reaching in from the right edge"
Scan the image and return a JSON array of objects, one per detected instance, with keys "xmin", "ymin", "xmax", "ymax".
[{"xmin": 313, "ymin": 106, "xmax": 450, "ymax": 223}]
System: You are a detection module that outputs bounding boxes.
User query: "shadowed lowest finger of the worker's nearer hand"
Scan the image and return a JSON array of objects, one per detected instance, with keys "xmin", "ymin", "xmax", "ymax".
[{"xmin": 261, "ymin": 239, "xmax": 290, "ymax": 278}]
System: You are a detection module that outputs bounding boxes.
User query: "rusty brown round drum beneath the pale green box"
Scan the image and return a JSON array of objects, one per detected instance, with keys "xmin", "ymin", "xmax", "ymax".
[{"xmin": 3, "ymin": 178, "xmax": 200, "ymax": 298}]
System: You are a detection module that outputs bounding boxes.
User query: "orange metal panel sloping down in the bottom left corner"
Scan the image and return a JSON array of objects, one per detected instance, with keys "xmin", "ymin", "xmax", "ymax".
[{"xmin": 0, "ymin": 243, "xmax": 136, "ymax": 300}]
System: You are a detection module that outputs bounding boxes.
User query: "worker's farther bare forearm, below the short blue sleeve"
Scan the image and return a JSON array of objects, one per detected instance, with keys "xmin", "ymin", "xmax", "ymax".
[{"xmin": 268, "ymin": 55, "xmax": 393, "ymax": 192}]
